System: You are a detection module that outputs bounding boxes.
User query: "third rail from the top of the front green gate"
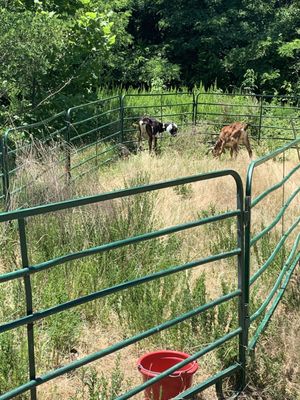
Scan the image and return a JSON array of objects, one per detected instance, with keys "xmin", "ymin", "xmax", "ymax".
[{"xmin": 0, "ymin": 249, "xmax": 241, "ymax": 334}]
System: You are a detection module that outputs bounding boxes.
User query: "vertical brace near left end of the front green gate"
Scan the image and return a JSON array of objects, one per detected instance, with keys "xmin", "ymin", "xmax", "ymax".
[{"xmin": 18, "ymin": 218, "xmax": 37, "ymax": 400}]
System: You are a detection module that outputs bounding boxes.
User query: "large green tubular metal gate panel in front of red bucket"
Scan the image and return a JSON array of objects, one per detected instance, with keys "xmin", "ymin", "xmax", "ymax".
[{"xmin": 0, "ymin": 170, "xmax": 249, "ymax": 400}]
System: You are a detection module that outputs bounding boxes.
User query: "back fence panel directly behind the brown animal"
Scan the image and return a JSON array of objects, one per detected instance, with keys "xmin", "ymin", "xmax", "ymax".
[{"xmin": 195, "ymin": 93, "xmax": 299, "ymax": 141}]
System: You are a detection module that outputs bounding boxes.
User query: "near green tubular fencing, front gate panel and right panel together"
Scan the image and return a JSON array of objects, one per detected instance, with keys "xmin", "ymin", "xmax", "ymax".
[{"xmin": 0, "ymin": 139, "xmax": 300, "ymax": 400}]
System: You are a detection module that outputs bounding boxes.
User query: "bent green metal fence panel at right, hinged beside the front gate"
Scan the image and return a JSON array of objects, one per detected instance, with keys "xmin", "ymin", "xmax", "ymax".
[{"xmin": 245, "ymin": 138, "xmax": 300, "ymax": 350}]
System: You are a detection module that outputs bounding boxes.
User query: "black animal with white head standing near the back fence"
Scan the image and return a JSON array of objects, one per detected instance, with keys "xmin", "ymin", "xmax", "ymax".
[{"xmin": 138, "ymin": 117, "xmax": 178, "ymax": 153}]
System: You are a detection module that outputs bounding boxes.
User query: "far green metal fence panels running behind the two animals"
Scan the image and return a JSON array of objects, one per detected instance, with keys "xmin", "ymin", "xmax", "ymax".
[{"xmin": 0, "ymin": 92, "xmax": 300, "ymax": 209}]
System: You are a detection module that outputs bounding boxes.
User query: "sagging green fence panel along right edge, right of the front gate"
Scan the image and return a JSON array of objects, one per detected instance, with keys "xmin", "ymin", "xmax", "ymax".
[{"xmin": 245, "ymin": 139, "xmax": 300, "ymax": 350}]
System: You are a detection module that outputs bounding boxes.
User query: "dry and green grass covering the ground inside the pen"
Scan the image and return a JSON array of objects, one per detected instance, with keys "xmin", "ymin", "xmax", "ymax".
[{"xmin": 0, "ymin": 127, "xmax": 300, "ymax": 400}]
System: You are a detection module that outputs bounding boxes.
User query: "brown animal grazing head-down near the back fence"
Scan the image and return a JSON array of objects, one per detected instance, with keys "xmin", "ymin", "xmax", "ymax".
[{"xmin": 212, "ymin": 122, "xmax": 252, "ymax": 158}]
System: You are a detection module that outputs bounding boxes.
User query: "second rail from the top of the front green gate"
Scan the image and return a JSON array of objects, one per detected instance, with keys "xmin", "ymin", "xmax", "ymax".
[{"xmin": 0, "ymin": 211, "xmax": 240, "ymax": 282}]
